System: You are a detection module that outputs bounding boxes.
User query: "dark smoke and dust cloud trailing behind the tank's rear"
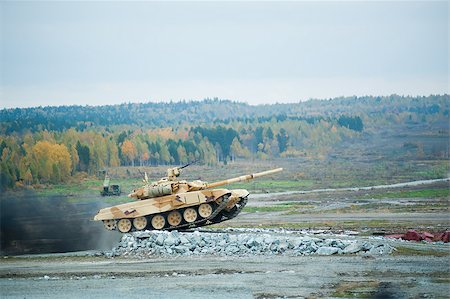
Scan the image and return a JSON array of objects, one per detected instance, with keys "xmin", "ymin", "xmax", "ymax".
[{"xmin": 0, "ymin": 191, "xmax": 120, "ymax": 255}]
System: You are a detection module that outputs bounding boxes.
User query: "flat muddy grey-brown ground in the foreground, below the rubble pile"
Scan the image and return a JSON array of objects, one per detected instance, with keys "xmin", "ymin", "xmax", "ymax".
[{"xmin": 0, "ymin": 248, "xmax": 450, "ymax": 298}]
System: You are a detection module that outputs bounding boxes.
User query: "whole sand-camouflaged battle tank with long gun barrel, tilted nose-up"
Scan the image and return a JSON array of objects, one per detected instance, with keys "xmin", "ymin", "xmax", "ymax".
[{"xmin": 94, "ymin": 164, "xmax": 283, "ymax": 233}]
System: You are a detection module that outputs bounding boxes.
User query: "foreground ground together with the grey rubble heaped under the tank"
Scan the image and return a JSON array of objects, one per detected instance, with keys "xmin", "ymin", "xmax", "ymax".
[{"xmin": 0, "ymin": 229, "xmax": 450, "ymax": 298}]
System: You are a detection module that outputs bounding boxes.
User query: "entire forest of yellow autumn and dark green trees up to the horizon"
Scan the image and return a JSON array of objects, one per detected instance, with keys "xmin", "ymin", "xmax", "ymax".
[{"xmin": 0, "ymin": 95, "xmax": 450, "ymax": 190}]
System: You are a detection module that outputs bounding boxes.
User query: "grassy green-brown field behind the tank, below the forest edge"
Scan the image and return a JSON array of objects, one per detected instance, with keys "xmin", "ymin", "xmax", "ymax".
[{"xmin": 24, "ymin": 159, "xmax": 448, "ymax": 201}]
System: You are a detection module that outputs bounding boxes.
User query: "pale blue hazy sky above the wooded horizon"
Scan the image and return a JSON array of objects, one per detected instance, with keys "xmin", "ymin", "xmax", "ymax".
[{"xmin": 0, "ymin": 1, "xmax": 449, "ymax": 108}]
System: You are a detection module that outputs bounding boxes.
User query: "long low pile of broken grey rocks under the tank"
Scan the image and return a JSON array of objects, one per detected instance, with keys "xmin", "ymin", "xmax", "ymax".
[{"xmin": 105, "ymin": 231, "xmax": 394, "ymax": 257}]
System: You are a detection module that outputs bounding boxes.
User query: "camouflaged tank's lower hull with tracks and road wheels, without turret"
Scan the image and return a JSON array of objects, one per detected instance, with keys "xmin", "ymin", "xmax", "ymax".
[{"xmin": 94, "ymin": 189, "xmax": 249, "ymax": 233}]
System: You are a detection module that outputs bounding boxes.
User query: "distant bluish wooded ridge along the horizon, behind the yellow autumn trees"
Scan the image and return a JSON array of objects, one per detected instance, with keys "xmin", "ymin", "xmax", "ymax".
[{"xmin": 0, "ymin": 95, "xmax": 449, "ymax": 135}]
